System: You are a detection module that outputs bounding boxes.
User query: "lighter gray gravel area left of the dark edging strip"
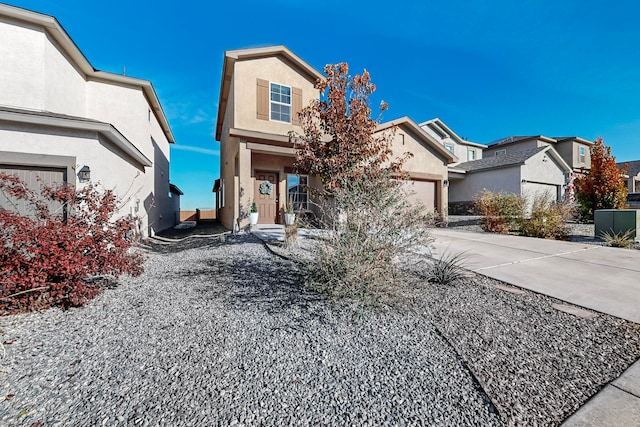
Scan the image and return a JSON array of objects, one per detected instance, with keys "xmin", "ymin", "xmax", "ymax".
[{"xmin": 0, "ymin": 235, "xmax": 502, "ymax": 426}]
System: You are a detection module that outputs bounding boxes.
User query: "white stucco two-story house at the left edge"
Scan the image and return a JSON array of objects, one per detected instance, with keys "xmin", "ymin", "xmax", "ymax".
[{"xmin": 0, "ymin": 4, "xmax": 181, "ymax": 235}]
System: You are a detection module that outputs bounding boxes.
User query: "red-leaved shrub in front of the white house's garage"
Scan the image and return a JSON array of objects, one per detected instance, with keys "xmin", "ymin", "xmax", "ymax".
[{"xmin": 0, "ymin": 173, "xmax": 142, "ymax": 314}]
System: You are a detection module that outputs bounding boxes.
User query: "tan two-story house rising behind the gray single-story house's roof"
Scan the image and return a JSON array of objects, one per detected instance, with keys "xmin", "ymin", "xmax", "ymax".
[{"xmin": 483, "ymin": 135, "xmax": 593, "ymax": 173}]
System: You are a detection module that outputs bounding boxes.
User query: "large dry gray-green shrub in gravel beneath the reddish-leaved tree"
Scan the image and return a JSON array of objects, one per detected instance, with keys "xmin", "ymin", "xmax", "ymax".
[{"xmin": 307, "ymin": 177, "xmax": 431, "ymax": 304}]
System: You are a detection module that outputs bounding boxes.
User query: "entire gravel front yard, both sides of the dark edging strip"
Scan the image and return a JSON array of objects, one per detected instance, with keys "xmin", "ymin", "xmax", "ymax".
[{"xmin": 0, "ymin": 235, "xmax": 640, "ymax": 426}]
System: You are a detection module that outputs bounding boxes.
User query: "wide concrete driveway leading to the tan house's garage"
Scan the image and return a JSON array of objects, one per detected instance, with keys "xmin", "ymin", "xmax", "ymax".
[{"xmin": 433, "ymin": 229, "xmax": 640, "ymax": 323}]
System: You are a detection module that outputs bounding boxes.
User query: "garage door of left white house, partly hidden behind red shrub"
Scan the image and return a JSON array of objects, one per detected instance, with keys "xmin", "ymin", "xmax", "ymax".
[{"xmin": 0, "ymin": 164, "xmax": 67, "ymax": 215}]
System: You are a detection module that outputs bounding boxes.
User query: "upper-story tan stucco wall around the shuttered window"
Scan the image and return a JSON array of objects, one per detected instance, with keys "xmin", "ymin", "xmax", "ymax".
[{"xmin": 234, "ymin": 57, "xmax": 319, "ymax": 135}]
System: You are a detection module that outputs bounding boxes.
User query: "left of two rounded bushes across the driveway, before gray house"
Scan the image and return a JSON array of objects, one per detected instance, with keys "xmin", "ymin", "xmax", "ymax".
[{"xmin": 475, "ymin": 190, "xmax": 525, "ymax": 233}]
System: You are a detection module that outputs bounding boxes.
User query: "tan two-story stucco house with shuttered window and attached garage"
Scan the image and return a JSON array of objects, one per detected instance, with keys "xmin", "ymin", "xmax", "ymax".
[{"xmin": 214, "ymin": 46, "xmax": 457, "ymax": 228}]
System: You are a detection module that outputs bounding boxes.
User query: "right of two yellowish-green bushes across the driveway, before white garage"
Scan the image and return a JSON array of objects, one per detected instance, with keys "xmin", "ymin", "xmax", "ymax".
[{"xmin": 518, "ymin": 193, "xmax": 575, "ymax": 240}]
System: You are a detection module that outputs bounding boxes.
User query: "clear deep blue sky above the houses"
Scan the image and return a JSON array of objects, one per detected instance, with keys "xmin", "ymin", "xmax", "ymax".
[{"xmin": 9, "ymin": 0, "xmax": 640, "ymax": 209}]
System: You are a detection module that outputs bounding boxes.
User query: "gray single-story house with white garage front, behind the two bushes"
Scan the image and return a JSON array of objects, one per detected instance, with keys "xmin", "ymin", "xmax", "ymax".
[{"xmin": 449, "ymin": 144, "xmax": 571, "ymax": 214}]
